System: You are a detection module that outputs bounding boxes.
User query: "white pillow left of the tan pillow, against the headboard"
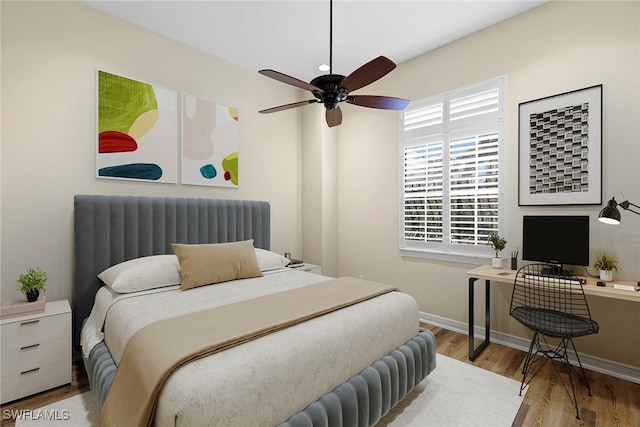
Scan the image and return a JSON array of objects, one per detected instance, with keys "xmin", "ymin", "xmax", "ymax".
[{"xmin": 98, "ymin": 255, "xmax": 182, "ymax": 294}]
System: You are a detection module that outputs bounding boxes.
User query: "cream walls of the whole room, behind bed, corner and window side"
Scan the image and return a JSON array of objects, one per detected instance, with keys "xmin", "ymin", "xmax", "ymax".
[{"xmin": 0, "ymin": 2, "xmax": 640, "ymax": 367}]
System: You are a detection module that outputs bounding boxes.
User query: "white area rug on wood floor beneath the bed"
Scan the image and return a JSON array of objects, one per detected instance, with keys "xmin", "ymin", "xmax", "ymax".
[{"xmin": 16, "ymin": 354, "xmax": 524, "ymax": 427}]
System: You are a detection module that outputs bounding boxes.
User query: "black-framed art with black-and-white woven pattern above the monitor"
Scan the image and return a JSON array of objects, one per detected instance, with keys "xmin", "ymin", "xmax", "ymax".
[{"xmin": 518, "ymin": 85, "xmax": 602, "ymax": 206}]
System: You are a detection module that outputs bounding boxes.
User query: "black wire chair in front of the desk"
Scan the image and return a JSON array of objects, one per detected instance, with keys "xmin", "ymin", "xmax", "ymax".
[{"xmin": 509, "ymin": 264, "xmax": 599, "ymax": 419}]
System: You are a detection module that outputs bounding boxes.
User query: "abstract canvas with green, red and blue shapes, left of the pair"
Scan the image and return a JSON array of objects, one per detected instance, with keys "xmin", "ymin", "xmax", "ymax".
[{"xmin": 96, "ymin": 70, "xmax": 178, "ymax": 183}]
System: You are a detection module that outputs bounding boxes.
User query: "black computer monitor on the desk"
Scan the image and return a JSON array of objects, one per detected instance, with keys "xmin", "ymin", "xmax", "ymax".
[{"xmin": 522, "ymin": 215, "xmax": 589, "ymax": 269}]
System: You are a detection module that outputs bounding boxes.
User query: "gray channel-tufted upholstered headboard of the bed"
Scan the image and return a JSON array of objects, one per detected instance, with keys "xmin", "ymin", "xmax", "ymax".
[{"xmin": 73, "ymin": 195, "xmax": 271, "ymax": 347}]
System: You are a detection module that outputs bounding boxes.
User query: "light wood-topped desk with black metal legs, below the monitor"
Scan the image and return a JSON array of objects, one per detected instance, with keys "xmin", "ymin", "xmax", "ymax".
[{"xmin": 467, "ymin": 265, "xmax": 640, "ymax": 360}]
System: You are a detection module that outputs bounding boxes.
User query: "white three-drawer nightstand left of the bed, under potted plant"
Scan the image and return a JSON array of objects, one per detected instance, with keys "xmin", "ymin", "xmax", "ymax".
[{"xmin": 0, "ymin": 300, "xmax": 71, "ymax": 403}]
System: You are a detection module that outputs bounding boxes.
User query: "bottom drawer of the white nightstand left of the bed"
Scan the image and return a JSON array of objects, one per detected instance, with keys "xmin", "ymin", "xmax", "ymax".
[{"xmin": 0, "ymin": 360, "xmax": 71, "ymax": 403}]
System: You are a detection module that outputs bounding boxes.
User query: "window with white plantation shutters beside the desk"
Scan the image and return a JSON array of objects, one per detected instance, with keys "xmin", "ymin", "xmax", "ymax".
[{"xmin": 400, "ymin": 77, "xmax": 506, "ymax": 262}]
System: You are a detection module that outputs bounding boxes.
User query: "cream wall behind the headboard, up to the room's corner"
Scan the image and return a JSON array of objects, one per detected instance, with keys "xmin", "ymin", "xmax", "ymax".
[{"xmin": 0, "ymin": 2, "xmax": 301, "ymax": 301}]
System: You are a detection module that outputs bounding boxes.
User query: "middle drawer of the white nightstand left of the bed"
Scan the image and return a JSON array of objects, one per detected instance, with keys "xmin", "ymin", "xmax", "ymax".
[{"xmin": 0, "ymin": 337, "xmax": 71, "ymax": 382}]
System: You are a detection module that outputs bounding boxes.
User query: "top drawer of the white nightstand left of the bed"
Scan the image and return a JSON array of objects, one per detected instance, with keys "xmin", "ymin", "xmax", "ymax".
[{"xmin": 0, "ymin": 312, "xmax": 71, "ymax": 353}]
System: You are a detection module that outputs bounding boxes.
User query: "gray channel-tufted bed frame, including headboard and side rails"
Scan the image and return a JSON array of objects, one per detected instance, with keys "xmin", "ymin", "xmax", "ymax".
[{"xmin": 73, "ymin": 195, "xmax": 435, "ymax": 427}]
